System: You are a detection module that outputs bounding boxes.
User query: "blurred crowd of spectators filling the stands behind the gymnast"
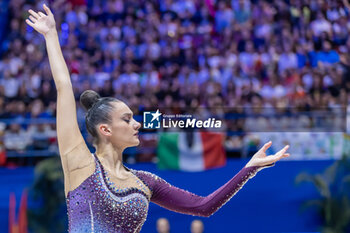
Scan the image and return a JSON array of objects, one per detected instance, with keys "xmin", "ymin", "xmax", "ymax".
[{"xmin": 0, "ymin": 0, "xmax": 350, "ymax": 157}]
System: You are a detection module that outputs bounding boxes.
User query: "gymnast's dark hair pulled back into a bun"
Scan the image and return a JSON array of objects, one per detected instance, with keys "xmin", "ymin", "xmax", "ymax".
[{"xmin": 80, "ymin": 90, "xmax": 120, "ymax": 143}]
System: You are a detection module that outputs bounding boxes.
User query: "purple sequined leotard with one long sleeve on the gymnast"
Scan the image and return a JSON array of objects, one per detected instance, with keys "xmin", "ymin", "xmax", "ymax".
[{"xmin": 67, "ymin": 155, "xmax": 274, "ymax": 233}]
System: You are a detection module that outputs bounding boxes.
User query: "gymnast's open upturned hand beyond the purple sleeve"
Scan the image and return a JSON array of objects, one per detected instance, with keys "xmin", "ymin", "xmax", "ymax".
[{"xmin": 245, "ymin": 141, "xmax": 290, "ymax": 167}]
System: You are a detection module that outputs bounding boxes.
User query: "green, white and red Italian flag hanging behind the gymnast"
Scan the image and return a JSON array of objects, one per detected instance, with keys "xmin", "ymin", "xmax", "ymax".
[{"xmin": 157, "ymin": 132, "xmax": 226, "ymax": 172}]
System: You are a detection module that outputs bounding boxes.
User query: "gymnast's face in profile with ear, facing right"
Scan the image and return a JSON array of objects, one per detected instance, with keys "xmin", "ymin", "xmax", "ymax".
[{"xmin": 99, "ymin": 102, "xmax": 141, "ymax": 149}]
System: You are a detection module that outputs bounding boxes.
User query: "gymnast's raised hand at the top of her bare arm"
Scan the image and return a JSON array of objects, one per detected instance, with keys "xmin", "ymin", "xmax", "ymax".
[{"xmin": 26, "ymin": 4, "xmax": 56, "ymax": 36}]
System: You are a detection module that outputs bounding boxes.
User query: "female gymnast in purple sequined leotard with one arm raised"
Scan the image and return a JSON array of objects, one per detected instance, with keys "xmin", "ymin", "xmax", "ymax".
[{"xmin": 26, "ymin": 5, "xmax": 289, "ymax": 232}]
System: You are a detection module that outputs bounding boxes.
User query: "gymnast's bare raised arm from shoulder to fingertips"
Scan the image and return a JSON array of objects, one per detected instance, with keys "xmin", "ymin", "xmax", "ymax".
[{"xmin": 26, "ymin": 4, "xmax": 94, "ymax": 195}]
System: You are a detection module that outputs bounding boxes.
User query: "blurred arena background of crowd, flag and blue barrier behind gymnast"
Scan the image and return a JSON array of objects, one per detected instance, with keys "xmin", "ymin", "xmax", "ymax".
[{"xmin": 0, "ymin": 0, "xmax": 350, "ymax": 233}]
